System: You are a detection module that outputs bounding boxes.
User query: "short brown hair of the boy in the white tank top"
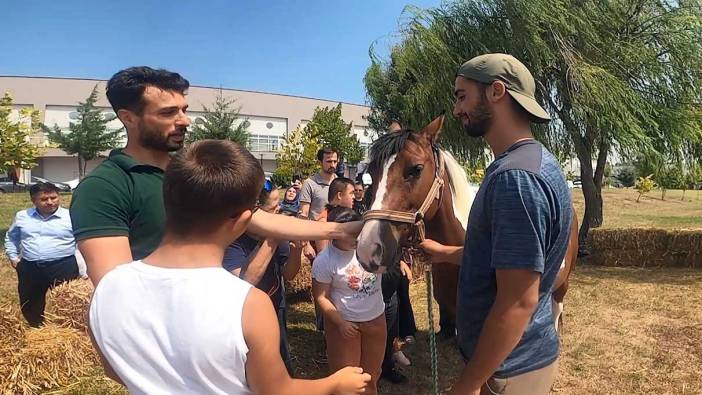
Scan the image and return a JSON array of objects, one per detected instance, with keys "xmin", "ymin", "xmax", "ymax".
[{"xmin": 163, "ymin": 140, "xmax": 263, "ymax": 236}]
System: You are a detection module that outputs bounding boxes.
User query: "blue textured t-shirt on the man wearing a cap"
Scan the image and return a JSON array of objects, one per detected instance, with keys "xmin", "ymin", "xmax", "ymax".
[{"xmin": 457, "ymin": 140, "xmax": 572, "ymax": 377}]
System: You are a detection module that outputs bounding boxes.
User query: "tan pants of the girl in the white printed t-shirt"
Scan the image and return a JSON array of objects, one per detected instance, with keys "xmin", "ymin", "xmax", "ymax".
[{"xmin": 324, "ymin": 314, "xmax": 386, "ymax": 395}]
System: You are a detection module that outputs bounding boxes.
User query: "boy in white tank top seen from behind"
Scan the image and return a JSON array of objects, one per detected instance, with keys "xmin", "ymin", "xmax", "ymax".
[{"xmin": 89, "ymin": 140, "xmax": 370, "ymax": 395}]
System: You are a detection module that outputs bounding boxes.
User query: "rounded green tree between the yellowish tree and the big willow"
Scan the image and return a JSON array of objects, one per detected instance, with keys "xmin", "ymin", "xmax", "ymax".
[{"xmin": 304, "ymin": 103, "xmax": 363, "ymax": 165}]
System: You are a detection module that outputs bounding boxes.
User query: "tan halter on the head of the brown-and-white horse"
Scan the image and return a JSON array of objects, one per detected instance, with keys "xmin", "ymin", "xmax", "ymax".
[{"xmin": 363, "ymin": 144, "xmax": 446, "ymax": 244}]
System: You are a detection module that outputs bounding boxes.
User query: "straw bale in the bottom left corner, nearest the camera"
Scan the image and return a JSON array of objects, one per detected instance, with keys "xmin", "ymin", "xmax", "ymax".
[{"xmin": 0, "ymin": 312, "xmax": 99, "ymax": 394}]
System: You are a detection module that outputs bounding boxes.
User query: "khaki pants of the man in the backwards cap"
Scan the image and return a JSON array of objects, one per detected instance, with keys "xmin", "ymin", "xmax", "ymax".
[{"xmin": 480, "ymin": 360, "xmax": 558, "ymax": 395}]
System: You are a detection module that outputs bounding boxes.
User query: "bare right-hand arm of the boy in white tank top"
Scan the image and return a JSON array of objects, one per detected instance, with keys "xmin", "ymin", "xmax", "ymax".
[{"xmin": 242, "ymin": 288, "xmax": 370, "ymax": 395}]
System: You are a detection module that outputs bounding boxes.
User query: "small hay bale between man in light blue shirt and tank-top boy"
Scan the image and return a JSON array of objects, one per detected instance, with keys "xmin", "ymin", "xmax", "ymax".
[{"xmin": 44, "ymin": 279, "xmax": 93, "ymax": 333}]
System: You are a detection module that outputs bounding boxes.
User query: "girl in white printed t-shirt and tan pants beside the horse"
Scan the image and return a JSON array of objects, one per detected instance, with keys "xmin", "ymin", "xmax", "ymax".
[{"xmin": 312, "ymin": 207, "xmax": 386, "ymax": 394}]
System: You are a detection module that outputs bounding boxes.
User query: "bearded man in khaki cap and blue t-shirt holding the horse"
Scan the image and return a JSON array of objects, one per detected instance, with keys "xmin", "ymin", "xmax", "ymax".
[{"xmin": 422, "ymin": 54, "xmax": 572, "ymax": 395}]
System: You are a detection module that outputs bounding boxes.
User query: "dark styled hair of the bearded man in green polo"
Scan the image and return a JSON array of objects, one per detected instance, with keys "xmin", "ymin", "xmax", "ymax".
[{"xmin": 107, "ymin": 66, "xmax": 190, "ymax": 114}]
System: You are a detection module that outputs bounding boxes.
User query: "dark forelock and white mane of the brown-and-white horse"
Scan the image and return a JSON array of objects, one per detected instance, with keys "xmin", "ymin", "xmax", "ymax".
[{"xmin": 368, "ymin": 129, "xmax": 477, "ymax": 229}]
